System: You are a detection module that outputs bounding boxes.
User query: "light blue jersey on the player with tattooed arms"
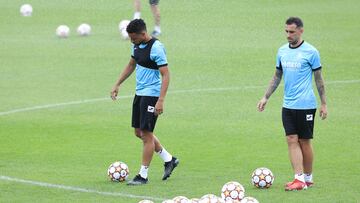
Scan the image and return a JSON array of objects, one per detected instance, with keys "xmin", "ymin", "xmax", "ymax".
[{"xmin": 276, "ymin": 41, "xmax": 321, "ymax": 109}]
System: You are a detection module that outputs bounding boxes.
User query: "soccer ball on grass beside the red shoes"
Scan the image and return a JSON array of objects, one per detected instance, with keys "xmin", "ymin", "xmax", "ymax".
[{"xmin": 251, "ymin": 167, "xmax": 275, "ymax": 189}]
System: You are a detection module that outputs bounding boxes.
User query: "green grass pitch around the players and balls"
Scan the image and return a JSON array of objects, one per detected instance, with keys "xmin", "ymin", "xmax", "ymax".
[{"xmin": 0, "ymin": 0, "xmax": 360, "ymax": 203}]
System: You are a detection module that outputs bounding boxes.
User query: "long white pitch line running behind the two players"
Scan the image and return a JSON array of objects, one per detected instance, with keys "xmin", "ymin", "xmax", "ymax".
[{"xmin": 0, "ymin": 80, "xmax": 360, "ymax": 116}]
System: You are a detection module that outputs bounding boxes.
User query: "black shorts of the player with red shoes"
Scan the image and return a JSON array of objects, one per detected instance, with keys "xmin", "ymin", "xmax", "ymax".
[{"xmin": 282, "ymin": 108, "xmax": 316, "ymax": 139}]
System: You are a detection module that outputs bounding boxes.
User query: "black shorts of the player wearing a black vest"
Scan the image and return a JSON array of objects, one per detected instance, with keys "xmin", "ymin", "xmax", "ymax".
[{"xmin": 132, "ymin": 95, "xmax": 158, "ymax": 132}]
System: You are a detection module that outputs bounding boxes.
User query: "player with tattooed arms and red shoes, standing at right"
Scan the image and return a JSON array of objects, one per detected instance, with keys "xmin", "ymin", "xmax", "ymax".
[{"xmin": 257, "ymin": 17, "xmax": 328, "ymax": 191}]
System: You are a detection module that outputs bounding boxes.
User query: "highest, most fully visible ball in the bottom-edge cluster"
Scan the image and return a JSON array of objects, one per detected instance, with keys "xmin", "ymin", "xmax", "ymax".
[{"xmin": 221, "ymin": 181, "xmax": 245, "ymax": 202}]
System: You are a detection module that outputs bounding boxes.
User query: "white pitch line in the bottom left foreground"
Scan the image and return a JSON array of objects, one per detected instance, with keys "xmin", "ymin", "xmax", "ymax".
[{"xmin": 0, "ymin": 176, "xmax": 165, "ymax": 201}]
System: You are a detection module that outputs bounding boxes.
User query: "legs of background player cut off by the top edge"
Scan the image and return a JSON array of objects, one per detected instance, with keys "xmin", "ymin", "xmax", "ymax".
[{"xmin": 134, "ymin": 0, "xmax": 161, "ymax": 37}]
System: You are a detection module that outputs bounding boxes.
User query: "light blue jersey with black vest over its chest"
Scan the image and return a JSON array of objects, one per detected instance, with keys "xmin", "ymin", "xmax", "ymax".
[{"xmin": 131, "ymin": 39, "xmax": 167, "ymax": 97}]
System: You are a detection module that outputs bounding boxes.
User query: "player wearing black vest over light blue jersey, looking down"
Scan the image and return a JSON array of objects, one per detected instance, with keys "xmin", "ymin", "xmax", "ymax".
[{"xmin": 110, "ymin": 19, "xmax": 179, "ymax": 185}]
